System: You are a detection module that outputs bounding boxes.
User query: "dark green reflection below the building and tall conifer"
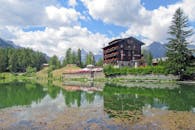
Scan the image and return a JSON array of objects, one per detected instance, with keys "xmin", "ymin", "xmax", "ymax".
[{"xmin": 104, "ymin": 84, "xmax": 195, "ymax": 111}]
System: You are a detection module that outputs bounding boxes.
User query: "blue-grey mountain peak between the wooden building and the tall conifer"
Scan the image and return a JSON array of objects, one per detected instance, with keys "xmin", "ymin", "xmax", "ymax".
[{"xmin": 146, "ymin": 42, "xmax": 166, "ymax": 58}]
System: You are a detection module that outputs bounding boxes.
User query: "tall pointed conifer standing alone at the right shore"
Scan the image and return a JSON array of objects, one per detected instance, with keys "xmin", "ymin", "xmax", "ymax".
[{"xmin": 166, "ymin": 8, "xmax": 192, "ymax": 80}]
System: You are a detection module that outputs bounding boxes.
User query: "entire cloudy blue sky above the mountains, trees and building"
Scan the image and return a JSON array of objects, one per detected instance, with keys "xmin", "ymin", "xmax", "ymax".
[{"xmin": 0, "ymin": 0, "xmax": 195, "ymax": 57}]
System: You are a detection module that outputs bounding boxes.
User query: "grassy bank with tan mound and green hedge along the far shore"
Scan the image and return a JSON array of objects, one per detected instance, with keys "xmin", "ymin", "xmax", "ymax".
[{"xmin": 0, "ymin": 66, "xmax": 187, "ymax": 84}]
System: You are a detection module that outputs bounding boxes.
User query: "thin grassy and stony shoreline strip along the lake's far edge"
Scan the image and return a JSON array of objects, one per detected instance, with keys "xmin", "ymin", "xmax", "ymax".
[{"xmin": 0, "ymin": 73, "xmax": 195, "ymax": 84}]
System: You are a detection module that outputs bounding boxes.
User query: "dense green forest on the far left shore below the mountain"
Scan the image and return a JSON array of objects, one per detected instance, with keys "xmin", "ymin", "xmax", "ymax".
[{"xmin": 0, "ymin": 48, "xmax": 47, "ymax": 72}]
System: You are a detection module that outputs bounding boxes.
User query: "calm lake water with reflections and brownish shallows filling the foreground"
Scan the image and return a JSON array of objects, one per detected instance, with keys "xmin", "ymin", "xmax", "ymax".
[{"xmin": 0, "ymin": 81, "xmax": 195, "ymax": 129}]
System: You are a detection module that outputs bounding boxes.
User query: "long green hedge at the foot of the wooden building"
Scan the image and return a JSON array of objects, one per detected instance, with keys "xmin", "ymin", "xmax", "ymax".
[{"xmin": 104, "ymin": 65, "xmax": 167, "ymax": 76}]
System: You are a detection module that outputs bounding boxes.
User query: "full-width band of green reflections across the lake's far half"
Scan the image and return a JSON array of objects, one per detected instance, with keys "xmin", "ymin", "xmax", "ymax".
[{"xmin": 0, "ymin": 82, "xmax": 195, "ymax": 111}]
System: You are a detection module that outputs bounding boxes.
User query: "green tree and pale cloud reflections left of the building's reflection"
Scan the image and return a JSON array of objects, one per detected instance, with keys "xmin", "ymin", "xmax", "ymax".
[{"xmin": 0, "ymin": 82, "xmax": 103, "ymax": 109}]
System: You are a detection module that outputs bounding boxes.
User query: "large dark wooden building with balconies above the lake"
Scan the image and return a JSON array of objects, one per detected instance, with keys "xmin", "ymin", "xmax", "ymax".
[{"xmin": 103, "ymin": 37, "xmax": 144, "ymax": 66}]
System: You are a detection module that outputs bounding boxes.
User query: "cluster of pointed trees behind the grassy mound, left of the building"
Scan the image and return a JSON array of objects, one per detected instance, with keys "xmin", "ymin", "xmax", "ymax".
[{"xmin": 49, "ymin": 48, "xmax": 103, "ymax": 69}]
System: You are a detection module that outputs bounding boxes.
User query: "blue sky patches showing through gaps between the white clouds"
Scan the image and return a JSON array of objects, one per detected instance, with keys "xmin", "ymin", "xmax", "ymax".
[{"xmin": 23, "ymin": 0, "xmax": 183, "ymax": 38}]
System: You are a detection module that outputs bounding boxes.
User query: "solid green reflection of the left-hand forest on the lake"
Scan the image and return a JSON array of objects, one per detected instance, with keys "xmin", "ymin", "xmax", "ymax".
[{"xmin": 0, "ymin": 82, "xmax": 46, "ymax": 108}]
